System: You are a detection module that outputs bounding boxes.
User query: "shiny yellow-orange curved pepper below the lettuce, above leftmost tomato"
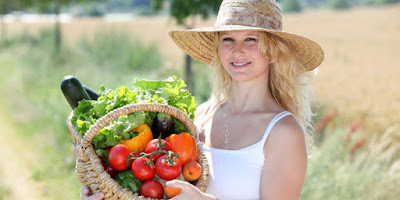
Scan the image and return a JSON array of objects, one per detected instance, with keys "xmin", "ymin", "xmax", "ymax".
[{"xmin": 120, "ymin": 124, "xmax": 153, "ymax": 153}]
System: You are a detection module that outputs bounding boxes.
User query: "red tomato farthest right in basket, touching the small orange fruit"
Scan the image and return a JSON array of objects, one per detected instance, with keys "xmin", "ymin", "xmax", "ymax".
[{"xmin": 156, "ymin": 155, "xmax": 182, "ymax": 181}]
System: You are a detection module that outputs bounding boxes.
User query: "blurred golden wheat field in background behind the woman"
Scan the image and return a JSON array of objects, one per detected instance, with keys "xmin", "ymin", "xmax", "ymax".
[{"xmin": 7, "ymin": 4, "xmax": 400, "ymax": 134}]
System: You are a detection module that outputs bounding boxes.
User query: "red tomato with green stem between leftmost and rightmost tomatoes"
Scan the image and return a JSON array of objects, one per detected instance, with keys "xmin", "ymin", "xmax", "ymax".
[{"xmin": 132, "ymin": 157, "xmax": 156, "ymax": 181}]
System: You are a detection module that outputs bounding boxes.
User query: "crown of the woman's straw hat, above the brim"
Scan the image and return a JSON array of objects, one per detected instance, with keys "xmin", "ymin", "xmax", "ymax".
[{"xmin": 214, "ymin": 0, "xmax": 282, "ymax": 31}]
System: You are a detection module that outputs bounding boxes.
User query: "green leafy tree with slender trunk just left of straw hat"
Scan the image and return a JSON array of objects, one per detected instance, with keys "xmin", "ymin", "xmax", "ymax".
[{"xmin": 151, "ymin": 0, "xmax": 222, "ymax": 94}]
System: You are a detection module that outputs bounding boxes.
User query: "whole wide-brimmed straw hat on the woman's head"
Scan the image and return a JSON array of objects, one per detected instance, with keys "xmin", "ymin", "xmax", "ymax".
[{"xmin": 169, "ymin": 0, "xmax": 324, "ymax": 70}]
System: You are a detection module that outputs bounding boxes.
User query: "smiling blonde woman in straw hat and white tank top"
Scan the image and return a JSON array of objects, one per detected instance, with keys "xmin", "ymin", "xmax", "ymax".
[{"xmin": 83, "ymin": 0, "xmax": 323, "ymax": 200}]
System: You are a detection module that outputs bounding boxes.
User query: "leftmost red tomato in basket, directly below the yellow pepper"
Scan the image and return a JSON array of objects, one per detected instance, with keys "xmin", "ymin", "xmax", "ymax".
[{"xmin": 108, "ymin": 144, "xmax": 131, "ymax": 171}]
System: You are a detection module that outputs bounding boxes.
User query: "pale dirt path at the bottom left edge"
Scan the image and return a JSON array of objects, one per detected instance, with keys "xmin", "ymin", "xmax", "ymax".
[{"xmin": 0, "ymin": 111, "xmax": 46, "ymax": 200}]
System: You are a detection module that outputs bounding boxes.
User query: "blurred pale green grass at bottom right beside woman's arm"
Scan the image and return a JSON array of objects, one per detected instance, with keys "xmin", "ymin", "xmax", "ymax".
[{"xmin": 301, "ymin": 121, "xmax": 400, "ymax": 200}]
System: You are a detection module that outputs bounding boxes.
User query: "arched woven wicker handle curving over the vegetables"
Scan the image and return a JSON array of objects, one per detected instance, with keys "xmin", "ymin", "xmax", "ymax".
[{"xmin": 82, "ymin": 103, "xmax": 197, "ymax": 148}]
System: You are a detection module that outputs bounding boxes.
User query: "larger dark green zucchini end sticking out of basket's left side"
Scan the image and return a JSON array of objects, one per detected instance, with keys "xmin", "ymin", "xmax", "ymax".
[{"xmin": 61, "ymin": 75, "xmax": 91, "ymax": 109}]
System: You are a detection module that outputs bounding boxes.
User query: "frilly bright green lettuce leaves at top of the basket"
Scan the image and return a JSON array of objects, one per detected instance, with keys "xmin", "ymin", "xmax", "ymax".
[{"xmin": 71, "ymin": 76, "xmax": 197, "ymax": 149}]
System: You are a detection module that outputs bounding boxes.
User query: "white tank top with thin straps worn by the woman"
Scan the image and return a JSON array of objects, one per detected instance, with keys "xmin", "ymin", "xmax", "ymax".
[{"xmin": 197, "ymin": 111, "xmax": 293, "ymax": 200}]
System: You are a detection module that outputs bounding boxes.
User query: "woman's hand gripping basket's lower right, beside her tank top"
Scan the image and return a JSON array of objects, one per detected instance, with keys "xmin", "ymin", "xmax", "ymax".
[{"xmin": 166, "ymin": 179, "xmax": 217, "ymax": 200}]
